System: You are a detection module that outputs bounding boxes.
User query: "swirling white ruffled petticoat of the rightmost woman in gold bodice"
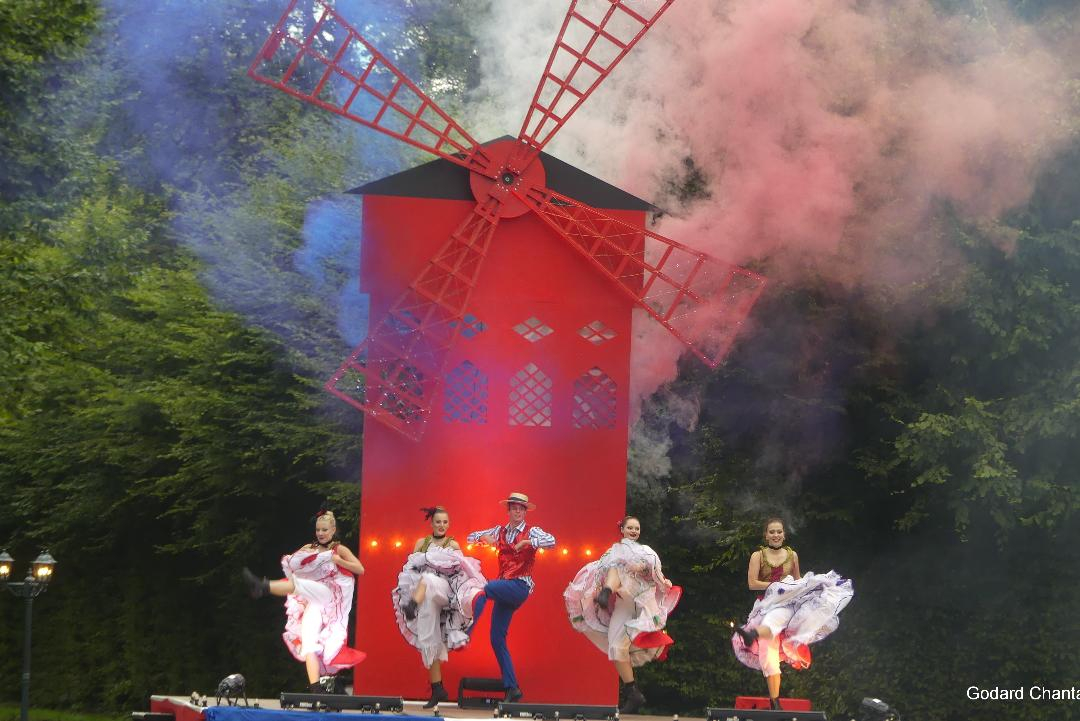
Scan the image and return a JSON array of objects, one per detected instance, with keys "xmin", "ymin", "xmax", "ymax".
[{"xmin": 731, "ymin": 571, "xmax": 855, "ymax": 670}]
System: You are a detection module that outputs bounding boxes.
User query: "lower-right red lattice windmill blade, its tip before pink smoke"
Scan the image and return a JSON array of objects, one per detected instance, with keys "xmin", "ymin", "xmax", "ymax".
[{"xmin": 519, "ymin": 189, "xmax": 766, "ymax": 368}]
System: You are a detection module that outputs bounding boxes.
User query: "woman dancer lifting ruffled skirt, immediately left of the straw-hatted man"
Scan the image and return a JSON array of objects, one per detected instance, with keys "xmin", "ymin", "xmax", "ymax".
[{"xmin": 391, "ymin": 506, "xmax": 487, "ymax": 708}]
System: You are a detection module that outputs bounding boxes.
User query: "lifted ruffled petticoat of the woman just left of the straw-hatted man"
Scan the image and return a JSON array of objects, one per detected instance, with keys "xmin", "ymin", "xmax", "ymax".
[{"xmin": 390, "ymin": 546, "xmax": 487, "ymax": 668}]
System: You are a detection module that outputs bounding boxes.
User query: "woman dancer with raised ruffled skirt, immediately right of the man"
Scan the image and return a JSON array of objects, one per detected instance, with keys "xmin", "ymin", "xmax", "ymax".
[{"xmin": 563, "ymin": 516, "xmax": 683, "ymax": 713}]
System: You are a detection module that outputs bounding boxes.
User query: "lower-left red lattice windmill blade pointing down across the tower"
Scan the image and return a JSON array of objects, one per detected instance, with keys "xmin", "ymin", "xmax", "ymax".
[{"xmin": 326, "ymin": 200, "xmax": 499, "ymax": 439}]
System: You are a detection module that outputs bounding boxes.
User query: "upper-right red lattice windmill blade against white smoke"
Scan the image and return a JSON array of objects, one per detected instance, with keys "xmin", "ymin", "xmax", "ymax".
[{"xmin": 517, "ymin": 0, "xmax": 675, "ymax": 154}]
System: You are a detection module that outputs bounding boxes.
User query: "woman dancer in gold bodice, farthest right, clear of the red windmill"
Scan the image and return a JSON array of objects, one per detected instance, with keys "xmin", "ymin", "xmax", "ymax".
[{"xmin": 731, "ymin": 518, "xmax": 854, "ymax": 709}]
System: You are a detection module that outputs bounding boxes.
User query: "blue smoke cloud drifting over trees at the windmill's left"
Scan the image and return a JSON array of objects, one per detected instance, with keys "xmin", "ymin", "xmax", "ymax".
[{"xmin": 102, "ymin": 0, "xmax": 421, "ymax": 366}]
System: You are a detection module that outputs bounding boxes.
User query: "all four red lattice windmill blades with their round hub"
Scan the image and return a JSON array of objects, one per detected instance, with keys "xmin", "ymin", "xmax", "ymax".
[{"xmin": 248, "ymin": 0, "xmax": 765, "ymax": 439}]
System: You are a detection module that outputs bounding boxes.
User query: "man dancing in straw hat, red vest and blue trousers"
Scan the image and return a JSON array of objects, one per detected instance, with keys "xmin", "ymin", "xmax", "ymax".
[{"xmin": 468, "ymin": 492, "xmax": 555, "ymax": 703}]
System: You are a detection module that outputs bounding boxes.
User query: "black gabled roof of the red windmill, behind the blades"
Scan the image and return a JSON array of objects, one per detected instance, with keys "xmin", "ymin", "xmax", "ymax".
[{"xmin": 349, "ymin": 136, "xmax": 653, "ymax": 210}]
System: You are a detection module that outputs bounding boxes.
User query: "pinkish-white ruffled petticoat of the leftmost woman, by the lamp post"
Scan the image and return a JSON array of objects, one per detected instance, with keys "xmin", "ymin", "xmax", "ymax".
[{"xmin": 281, "ymin": 549, "xmax": 365, "ymax": 676}]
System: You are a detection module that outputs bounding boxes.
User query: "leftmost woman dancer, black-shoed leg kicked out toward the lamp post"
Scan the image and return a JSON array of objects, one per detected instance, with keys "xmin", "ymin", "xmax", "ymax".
[{"xmin": 243, "ymin": 511, "xmax": 365, "ymax": 693}]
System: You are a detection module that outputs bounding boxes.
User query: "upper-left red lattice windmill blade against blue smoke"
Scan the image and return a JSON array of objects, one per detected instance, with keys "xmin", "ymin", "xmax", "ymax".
[{"xmin": 247, "ymin": 0, "xmax": 492, "ymax": 176}]
